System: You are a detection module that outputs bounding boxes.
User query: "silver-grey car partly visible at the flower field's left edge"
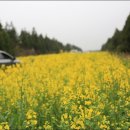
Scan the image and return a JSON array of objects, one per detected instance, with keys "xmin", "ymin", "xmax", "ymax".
[{"xmin": 0, "ymin": 50, "xmax": 20, "ymax": 65}]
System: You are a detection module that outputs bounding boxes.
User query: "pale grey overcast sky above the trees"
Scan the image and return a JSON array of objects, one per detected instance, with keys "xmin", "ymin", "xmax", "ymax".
[{"xmin": 0, "ymin": 1, "xmax": 130, "ymax": 50}]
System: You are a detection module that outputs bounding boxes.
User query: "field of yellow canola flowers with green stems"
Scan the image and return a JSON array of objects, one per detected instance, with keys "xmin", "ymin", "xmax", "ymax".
[{"xmin": 0, "ymin": 52, "xmax": 130, "ymax": 130}]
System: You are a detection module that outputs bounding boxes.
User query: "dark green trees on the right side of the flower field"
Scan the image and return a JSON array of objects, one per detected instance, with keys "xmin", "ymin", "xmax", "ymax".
[{"xmin": 101, "ymin": 15, "xmax": 130, "ymax": 52}]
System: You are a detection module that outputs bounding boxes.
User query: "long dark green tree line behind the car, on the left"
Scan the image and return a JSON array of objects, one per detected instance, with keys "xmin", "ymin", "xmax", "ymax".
[{"xmin": 0, "ymin": 23, "xmax": 82, "ymax": 56}]
